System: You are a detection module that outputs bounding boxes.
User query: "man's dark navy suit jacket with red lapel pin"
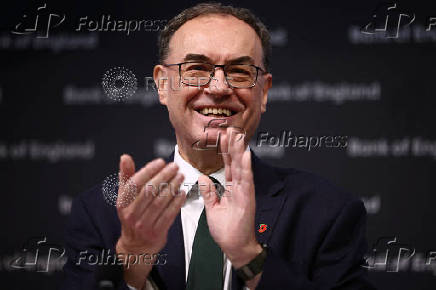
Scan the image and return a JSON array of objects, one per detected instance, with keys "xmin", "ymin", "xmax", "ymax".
[{"xmin": 62, "ymin": 154, "xmax": 374, "ymax": 289}]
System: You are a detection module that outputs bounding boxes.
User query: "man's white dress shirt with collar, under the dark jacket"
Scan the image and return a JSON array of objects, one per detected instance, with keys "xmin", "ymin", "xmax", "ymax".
[{"xmin": 128, "ymin": 145, "xmax": 238, "ymax": 290}]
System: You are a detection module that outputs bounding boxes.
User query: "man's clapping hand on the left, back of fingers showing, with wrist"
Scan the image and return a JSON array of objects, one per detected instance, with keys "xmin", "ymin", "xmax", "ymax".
[{"xmin": 116, "ymin": 154, "xmax": 186, "ymax": 289}]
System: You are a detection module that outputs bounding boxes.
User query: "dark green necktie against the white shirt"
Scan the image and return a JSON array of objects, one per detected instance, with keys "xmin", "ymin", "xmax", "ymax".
[{"xmin": 186, "ymin": 176, "xmax": 224, "ymax": 290}]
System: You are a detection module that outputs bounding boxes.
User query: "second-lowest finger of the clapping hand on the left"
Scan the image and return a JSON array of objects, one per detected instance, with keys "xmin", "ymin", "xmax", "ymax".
[{"xmin": 141, "ymin": 173, "xmax": 185, "ymax": 225}]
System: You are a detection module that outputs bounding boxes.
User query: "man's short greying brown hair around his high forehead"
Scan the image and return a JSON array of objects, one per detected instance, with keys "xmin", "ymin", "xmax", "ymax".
[{"xmin": 158, "ymin": 3, "xmax": 271, "ymax": 71}]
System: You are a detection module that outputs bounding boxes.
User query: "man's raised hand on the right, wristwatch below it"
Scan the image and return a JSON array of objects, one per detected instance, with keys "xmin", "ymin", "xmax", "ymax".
[{"xmin": 198, "ymin": 128, "xmax": 262, "ymax": 268}]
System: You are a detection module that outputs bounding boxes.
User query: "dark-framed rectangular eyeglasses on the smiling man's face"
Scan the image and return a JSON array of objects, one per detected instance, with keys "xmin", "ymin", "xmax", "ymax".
[{"xmin": 164, "ymin": 61, "xmax": 266, "ymax": 89}]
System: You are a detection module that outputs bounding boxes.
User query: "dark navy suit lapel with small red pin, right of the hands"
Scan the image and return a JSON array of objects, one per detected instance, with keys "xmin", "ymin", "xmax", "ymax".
[{"xmin": 232, "ymin": 151, "xmax": 285, "ymax": 290}]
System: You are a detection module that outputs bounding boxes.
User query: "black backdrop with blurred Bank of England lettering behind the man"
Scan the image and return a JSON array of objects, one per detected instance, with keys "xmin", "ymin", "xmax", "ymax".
[{"xmin": 0, "ymin": 0, "xmax": 436, "ymax": 289}]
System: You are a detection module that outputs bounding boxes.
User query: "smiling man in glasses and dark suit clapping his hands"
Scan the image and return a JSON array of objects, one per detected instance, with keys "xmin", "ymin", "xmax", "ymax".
[{"xmin": 64, "ymin": 4, "xmax": 372, "ymax": 289}]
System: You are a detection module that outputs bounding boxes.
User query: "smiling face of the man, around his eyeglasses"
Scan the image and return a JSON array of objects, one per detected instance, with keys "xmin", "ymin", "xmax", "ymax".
[{"xmin": 154, "ymin": 14, "xmax": 271, "ymax": 150}]
